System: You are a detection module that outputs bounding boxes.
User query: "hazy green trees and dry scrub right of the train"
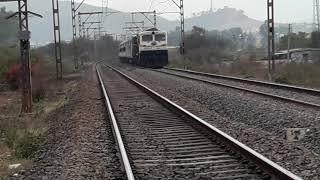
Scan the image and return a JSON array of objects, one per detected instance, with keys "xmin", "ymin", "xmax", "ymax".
[{"xmin": 170, "ymin": 26, "xmax": 320, "ymax": 88}]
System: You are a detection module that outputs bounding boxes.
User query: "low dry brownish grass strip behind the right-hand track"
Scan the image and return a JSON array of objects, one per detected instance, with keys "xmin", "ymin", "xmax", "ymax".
[{"xmin": 170, "ymin": 50, "xmax": 320, "ymax": 88}]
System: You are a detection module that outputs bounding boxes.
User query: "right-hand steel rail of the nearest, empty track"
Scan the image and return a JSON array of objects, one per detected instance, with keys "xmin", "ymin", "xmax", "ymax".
[{"xmin": 106, "ymin": 65, "xmax": 302, "ymax": 180}]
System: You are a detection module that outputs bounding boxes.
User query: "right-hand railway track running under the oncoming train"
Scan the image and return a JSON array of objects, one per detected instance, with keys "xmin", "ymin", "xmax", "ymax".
[{"xmin": 154, "ymin": 68, "xmax": 320, "ymax": 109}]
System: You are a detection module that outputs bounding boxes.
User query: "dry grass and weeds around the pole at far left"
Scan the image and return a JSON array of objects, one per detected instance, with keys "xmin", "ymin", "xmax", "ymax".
[{"xmin": 0, "ymin": 57, "xmax": 76, "ymax": 179}]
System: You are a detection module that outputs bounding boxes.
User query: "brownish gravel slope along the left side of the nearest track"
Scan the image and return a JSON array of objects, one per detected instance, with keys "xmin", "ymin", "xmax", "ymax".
[{"xmin": 13, "ymin": 68, "xmax": 125, "ymax": 180}]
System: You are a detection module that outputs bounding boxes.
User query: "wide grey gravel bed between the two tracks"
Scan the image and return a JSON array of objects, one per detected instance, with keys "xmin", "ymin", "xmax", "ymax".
[{"xmin": 116, "ymin": 65, "xmax": 320, "ymax": 179}]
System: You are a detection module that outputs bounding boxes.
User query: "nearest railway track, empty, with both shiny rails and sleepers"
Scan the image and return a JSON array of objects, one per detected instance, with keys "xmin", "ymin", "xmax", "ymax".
[{"xmin": 97, "ymin": 64, "xmax": 301, "ymax": 179}]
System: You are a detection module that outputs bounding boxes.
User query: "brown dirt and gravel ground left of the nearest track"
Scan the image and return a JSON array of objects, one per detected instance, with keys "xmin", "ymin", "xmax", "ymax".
[{"xmin": 0, "ymin": 66, "xmax": 124, "ymax": 179}]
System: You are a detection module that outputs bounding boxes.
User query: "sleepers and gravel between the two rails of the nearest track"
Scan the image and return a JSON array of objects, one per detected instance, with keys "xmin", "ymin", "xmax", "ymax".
[{"xmin": 103, "ymin": 68, "xmax": 264, "ymax": 179}]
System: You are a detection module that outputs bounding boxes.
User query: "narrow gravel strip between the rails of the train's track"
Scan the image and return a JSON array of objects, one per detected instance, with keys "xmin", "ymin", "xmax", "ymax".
[{"xmin": 161, "ymin": 69, "xmax": 320, "ymax": 104}]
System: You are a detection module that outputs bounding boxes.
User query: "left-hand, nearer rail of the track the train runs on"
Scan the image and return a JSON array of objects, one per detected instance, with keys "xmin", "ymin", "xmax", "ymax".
[{"xmin": 154, "ymin": 70, "xmax": 320, "ymax": 109}]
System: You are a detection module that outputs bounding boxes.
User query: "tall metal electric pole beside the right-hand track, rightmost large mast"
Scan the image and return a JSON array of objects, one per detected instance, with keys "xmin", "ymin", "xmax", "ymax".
[{"xmin": 267, "ymin": 0, "xmax": 275, "ymax": 80}]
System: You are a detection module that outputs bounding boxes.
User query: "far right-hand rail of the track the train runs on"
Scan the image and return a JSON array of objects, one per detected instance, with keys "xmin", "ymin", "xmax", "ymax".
[{"xmin": 164, "ymin": 68, "xmax": 320, "ymax": 96}]
